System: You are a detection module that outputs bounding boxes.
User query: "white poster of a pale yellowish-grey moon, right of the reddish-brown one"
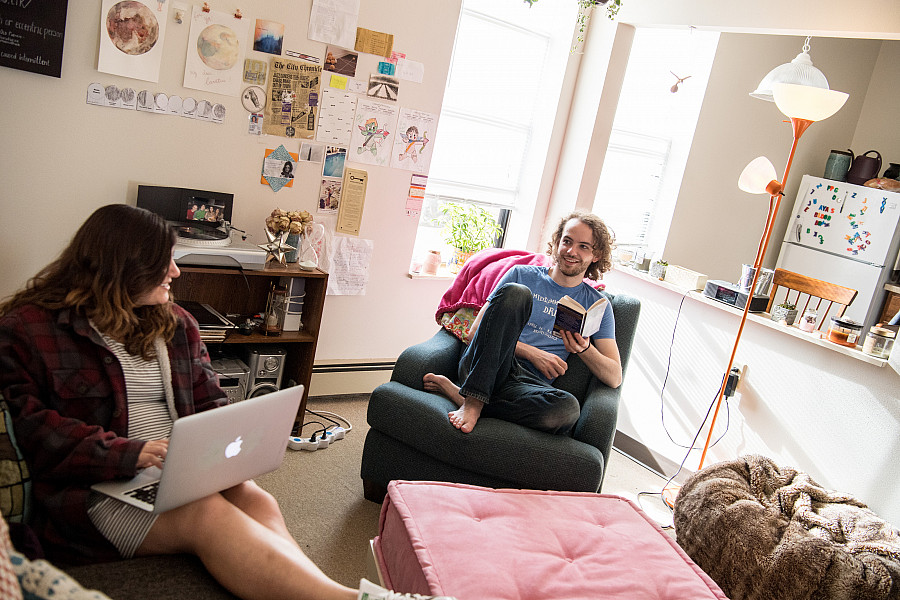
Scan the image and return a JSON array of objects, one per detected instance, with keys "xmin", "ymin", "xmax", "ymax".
[{"xmin": 184, "ymin": 5, "xmax": 248, "ymax": 96}]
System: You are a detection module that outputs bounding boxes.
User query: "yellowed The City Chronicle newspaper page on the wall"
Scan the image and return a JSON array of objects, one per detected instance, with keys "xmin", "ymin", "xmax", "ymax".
[{"xmin": 263, "ymin": 58, "xmax": 322, "ymax": 140}]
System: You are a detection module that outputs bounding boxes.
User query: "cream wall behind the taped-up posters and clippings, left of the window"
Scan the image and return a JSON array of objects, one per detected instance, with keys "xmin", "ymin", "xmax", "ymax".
[{"xmin": 0, "ymin": 0, "xmax": 461, "ymax": 360}]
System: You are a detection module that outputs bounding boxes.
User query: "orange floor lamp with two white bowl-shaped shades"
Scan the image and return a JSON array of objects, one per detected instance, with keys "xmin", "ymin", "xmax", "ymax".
[{"xmin": 663, "ymin": 83, "xmax": 849, "ymax": 506}]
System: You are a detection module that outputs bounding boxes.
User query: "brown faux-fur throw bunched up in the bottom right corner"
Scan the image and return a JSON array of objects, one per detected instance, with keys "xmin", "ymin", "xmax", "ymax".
[{"xmin": 674, "ymin": 456, "xmax": 900, "ymax": 600}]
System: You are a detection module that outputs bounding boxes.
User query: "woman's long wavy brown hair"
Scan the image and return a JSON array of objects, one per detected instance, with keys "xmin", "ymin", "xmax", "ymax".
[{"xmin": 0, "ymin": 204, "xmax": 176, "ymax": 359}]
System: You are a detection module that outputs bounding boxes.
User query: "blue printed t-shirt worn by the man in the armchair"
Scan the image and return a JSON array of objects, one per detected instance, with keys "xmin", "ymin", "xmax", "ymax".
[{"xmin": 488, "ymin": 265, "xmax": 616, "ymax": 381}]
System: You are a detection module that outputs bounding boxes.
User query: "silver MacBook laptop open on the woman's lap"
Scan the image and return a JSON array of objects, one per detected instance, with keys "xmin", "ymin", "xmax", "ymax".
[{"xmin": 91, "ymin": 385, "xmax": 303, "ymax": 513}]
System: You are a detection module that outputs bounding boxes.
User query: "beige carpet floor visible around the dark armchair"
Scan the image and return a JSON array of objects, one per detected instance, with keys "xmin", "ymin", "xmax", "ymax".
[{"xmin": 257, "ymin": 395, "xmax": 672, "ymax": 587}]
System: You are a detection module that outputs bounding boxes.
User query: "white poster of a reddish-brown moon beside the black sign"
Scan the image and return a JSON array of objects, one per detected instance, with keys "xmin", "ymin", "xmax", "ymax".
[{"xmin": 97, "ymin": 0, "xmax": 168, "ymax": 83}]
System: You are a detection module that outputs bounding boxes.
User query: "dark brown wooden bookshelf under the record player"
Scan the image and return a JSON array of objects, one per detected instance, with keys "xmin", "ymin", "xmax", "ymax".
[{"xmin": 172, "ymin": 262, "xmax": 328, "ymax": 425}]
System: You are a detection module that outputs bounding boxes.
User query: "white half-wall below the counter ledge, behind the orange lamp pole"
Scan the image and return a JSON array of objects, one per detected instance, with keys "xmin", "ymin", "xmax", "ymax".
[{"xmin": 607, "ymin": 271, "xmax": 900, "ymax": 524}]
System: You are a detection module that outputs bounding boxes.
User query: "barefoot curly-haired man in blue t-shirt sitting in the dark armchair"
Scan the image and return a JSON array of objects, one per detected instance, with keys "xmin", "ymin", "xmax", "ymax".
[{"xmin": 424, "ymin": 212, "xmax": 622, "ymax": 434}]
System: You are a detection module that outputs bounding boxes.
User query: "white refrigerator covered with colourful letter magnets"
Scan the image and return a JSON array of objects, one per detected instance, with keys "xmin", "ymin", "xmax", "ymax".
[{"xmin": 775, "ymin": 175, "xmax": 900, "ymax": 335}]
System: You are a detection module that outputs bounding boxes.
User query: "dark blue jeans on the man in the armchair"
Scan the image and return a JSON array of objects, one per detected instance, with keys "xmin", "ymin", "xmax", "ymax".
[{"xmin": 459, "ymin": 283, "xmax": 581, "ymax": 434}]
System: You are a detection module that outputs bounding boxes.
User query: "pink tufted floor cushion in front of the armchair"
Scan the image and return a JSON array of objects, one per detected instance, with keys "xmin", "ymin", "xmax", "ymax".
[{"xmin": 375, "ymin": 481, "xmax": 727, "ymax": 600}]
